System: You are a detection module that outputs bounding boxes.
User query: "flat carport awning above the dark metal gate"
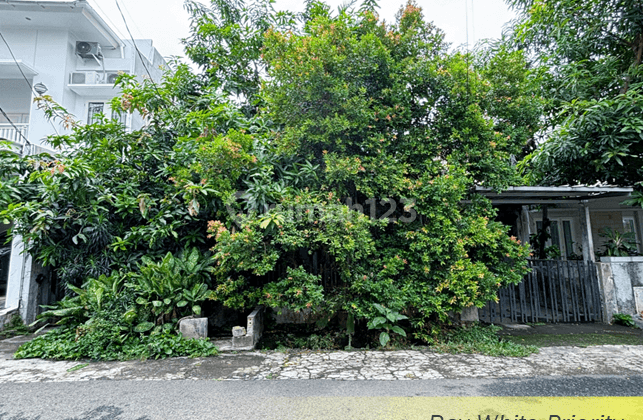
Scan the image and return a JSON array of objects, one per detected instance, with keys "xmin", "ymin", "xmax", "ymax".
[{"xmin": 476, "ymin": 185, "xmax": 634, "ymax": 205}]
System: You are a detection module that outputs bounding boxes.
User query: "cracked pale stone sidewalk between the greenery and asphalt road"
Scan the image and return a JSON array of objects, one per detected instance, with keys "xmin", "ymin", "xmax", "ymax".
[{"xmin": 0, "ymin": 337, "xmax": 643, "ymax": 383}]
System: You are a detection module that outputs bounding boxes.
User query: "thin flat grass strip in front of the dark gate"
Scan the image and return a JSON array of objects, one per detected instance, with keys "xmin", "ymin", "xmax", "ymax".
[{"xmin": 504, "ymin": 333, "xmax": 643, "ymax": 347}]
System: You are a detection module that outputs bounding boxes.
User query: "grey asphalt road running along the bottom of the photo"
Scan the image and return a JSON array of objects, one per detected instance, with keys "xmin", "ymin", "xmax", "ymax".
[{"xmin": 0, "ymin": 376, "xmax": 643, "ymax": 420}]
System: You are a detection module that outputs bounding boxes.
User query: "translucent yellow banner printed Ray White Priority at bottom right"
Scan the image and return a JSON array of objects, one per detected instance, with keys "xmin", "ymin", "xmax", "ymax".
[{"xmin": 271, "ymin": 397, "xmax": 643, "ymax": 420}]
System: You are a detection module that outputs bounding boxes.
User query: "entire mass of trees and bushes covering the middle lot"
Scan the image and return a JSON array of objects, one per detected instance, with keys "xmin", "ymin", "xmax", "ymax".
[{"xmin": 0, "ymin": 0, "xmax": 541, "ymax": 357}]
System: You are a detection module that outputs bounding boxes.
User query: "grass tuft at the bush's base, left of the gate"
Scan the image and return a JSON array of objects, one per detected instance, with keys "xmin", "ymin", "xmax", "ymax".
[{"xmin": 431, "ymin": 324, "xmax": 538, "ymax": 357}]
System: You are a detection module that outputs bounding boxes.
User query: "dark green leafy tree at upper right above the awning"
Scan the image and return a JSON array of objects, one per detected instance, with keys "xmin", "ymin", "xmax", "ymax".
[{"xmin": 508, "ymin": 0, "xmax": 643, "ymax": 186}]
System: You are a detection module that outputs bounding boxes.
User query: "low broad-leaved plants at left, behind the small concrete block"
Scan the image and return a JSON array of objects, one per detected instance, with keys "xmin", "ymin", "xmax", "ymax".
[{"xmin": 40, "ymin": 248, "xmax": 219, "ymax": 334}]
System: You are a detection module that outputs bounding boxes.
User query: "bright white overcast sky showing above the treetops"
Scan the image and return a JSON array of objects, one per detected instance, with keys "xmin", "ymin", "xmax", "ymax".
[{"xmin": 89, "ymin": 0, "xmax": 515, "ymax": 57}]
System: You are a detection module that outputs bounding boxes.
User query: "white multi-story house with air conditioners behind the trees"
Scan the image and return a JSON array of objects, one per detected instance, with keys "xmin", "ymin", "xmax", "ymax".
[{"xmin": 0, "ymin": 0, "xmax": 165, "ymax": 321}]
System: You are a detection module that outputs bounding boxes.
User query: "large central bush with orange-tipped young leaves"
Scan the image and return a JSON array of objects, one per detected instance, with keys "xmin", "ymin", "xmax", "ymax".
[{"xmin": 200, "ymin": 3, "xmax": 538, "ymax": 335}]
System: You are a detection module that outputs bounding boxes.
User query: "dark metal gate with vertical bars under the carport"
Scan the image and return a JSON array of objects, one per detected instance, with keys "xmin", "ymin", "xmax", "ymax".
[{"xmin": 479, "ymin": 260, "xmax": 602, "ymax": 323}]
